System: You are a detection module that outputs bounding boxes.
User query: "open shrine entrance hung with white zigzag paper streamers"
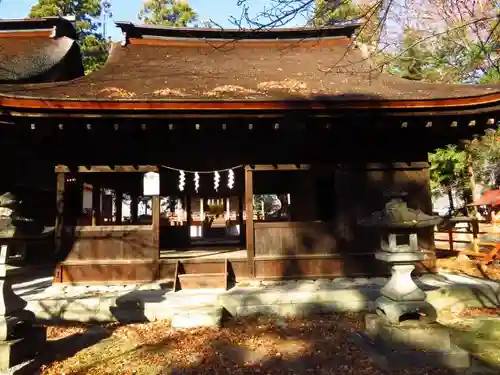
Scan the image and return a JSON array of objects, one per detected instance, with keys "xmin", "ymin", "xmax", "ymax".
[{"xmin": 160, "ymin": 168, "xmax": 246, "ymax": 257}]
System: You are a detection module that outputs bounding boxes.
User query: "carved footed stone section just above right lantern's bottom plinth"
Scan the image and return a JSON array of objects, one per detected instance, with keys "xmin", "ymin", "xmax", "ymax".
[{"xmin": 375, "ymin": 296, "xmax": 437, "ymax": 325}]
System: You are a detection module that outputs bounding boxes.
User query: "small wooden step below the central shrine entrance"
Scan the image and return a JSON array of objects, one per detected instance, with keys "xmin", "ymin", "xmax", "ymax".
[{"xmin": 174, "ymin": 259, "xmax": 228, "ymax": 291}]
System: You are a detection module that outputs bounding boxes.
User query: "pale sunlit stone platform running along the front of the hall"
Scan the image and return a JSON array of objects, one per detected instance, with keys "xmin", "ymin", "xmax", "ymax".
[{"xmin": 10, "ymin": 275, "xmax": 500, "ymax": 325}]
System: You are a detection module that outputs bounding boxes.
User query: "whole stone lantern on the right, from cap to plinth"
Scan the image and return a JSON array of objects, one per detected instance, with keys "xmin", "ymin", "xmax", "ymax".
[{"xmin": 354, "ymin": 192, "xmax": 470, "ymax": 368}]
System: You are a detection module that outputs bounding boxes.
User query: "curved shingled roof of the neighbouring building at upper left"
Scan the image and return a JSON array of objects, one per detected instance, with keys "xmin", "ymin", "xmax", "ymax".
[{"xmin": 0, "ymin": 18, "xmax": 83, "ymax": 83}]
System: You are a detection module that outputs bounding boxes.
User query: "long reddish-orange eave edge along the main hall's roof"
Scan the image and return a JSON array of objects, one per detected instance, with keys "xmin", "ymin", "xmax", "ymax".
[{"xmin": 0, "ymin": 93, "xmax": 500, "ymax": 117}]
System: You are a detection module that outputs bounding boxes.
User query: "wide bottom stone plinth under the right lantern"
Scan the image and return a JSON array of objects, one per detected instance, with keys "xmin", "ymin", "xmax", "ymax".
[{"xmin": 350, "ymin": 314, "xmax": 471, "ymax": 370}]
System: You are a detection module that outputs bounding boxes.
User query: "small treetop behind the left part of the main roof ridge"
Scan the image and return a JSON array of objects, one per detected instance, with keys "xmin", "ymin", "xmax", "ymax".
[{"xmin": 137, "ymin": 0, "xmax": 198, "ymax": 27}]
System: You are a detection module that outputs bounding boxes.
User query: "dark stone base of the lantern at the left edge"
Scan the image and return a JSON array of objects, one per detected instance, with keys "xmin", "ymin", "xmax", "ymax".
[{"xmin": 0, "ymin": 327, "xmax": 47, "ymax": 371}]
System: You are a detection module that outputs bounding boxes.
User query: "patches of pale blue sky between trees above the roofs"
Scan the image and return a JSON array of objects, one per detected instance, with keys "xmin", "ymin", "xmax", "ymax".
[{"xmin": 0, "ymin": 0, "xmax": 305, "ymax": 40}]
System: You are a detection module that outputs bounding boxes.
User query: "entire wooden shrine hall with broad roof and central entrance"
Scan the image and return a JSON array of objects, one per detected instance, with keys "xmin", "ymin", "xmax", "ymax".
[{"xmin": 0, "ymin": 22, "xmax": 500, "ymax": 288}]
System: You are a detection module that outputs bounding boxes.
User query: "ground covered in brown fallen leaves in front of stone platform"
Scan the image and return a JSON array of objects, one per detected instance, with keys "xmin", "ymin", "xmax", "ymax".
[{"xmin": 41, "ymin": 315, "xmax": 451, "ymax": 375}]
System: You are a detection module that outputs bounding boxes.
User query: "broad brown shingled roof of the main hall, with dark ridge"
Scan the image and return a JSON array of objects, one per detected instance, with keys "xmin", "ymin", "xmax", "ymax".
[{"xmin": 0, "ymin": 23, "xmax": 500, "ymax": 112}]
